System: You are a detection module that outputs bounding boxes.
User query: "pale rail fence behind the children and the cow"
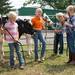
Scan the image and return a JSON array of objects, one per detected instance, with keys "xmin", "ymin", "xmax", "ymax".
[{"xmin": 4, "ymin": 30, "xmax": 67, "ymax": 52}]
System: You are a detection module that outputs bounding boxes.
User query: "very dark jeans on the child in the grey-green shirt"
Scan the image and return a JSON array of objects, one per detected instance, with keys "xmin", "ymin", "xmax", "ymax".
[{"xmin": 54, "ymin": 34, "xmax": 63, "ymax": 54}]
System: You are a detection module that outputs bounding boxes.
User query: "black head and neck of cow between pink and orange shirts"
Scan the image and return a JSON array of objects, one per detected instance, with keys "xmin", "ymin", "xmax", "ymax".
[{"xmin": 16, "ymin": 19, "xmax": 34, "ymax": 38}]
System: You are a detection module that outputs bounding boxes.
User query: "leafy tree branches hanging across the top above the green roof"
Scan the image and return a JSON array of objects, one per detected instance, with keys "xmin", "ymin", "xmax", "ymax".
[{"xmin": 24, "ymin": 0, "xmax": 72, "ymax": 10}]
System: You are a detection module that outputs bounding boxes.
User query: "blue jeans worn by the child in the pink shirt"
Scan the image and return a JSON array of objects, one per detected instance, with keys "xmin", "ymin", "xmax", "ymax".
[{"xmin": 8, "ymin": 43, "xmax": 24, "ymax": 67}]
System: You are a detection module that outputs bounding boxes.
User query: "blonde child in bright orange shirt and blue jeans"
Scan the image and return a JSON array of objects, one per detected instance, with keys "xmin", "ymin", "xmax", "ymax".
[{"xmin": 31, "ymin": 8, "xmax": 46, "ymax": 61}]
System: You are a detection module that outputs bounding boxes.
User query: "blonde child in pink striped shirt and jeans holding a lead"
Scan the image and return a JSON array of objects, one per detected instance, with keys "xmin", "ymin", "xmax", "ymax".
[{"xmin": 5, "ymin": 12, "xmax": 24, "ymax": 69}]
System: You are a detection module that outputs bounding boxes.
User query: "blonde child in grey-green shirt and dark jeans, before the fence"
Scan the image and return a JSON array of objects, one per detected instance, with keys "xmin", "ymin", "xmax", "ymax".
[{"xmin": 54, "ymin": 12, "xmax": 65, "ymax": 55}]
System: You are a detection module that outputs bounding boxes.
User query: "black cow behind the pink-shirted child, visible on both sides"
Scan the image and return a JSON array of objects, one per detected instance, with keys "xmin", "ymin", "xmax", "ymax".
[{"xmin": 0, "ymin": 17, "xmax": 35, "ymax": 38}]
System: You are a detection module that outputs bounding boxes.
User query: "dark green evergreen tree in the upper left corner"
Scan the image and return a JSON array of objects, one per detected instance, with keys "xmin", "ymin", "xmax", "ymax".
[{"xmin": 0, "ymin": 0, "xmax": 12, "ymax": 15}]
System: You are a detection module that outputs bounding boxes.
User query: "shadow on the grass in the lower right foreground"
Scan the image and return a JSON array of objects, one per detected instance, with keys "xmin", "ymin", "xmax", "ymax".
[{"xmin": 44, "ymin": 63, "xmax": 75, "ymax": 73}]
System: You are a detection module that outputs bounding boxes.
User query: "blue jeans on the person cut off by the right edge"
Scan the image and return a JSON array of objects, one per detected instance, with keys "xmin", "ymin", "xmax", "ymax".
[{"xmin": 67, "ymin": 31, "xmax": 75, "ymax": 53}]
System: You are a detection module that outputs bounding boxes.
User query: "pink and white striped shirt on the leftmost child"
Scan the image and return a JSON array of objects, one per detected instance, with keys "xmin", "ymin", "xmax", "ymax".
[{"xmin": 5, "ymin": 21, "xmax": 18, "ymax": 43}]
